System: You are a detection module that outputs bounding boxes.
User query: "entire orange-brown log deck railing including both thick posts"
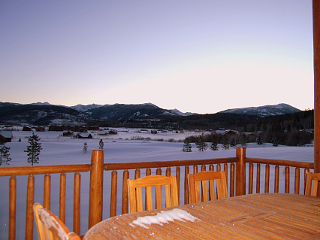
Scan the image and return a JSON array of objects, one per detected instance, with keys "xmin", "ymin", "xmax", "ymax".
[{"xmin": 0, "ymin": 148, "xmax": 314, "ymax": 240}]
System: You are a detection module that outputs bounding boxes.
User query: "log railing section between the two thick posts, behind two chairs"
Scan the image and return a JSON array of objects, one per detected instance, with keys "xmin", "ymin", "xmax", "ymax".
[{"xmin": 104, "ymin": 157, "xmax": 238, "ymax": 217}]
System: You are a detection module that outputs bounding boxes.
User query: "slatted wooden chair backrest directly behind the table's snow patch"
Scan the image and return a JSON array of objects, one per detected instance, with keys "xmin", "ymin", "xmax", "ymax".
[{"xmin": 128, "ymin": 175, "xmax": 179, "ymax": 213}]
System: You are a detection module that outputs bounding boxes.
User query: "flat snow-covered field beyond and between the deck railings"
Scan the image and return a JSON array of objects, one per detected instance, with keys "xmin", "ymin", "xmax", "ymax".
[{"xmin": 0, "ymin": 129, "xmax": 314, "ymax": 239}]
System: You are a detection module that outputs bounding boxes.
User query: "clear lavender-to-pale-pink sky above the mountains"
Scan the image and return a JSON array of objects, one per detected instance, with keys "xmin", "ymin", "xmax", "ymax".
[{"xmin": 0, "ymin": 0, "xmax": 313, "ymax": 113}]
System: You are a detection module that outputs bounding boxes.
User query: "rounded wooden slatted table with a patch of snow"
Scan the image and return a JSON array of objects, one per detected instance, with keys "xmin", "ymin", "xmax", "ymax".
[{"xmin": 84, "ymin": 194, "xmax": 320, "ymax": 240}]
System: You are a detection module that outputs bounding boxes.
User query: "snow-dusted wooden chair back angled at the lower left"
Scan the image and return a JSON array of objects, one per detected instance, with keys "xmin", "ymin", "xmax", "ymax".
[{"xmin": 33, "ymin": 203, "xmax": 80, "ymax": 240}]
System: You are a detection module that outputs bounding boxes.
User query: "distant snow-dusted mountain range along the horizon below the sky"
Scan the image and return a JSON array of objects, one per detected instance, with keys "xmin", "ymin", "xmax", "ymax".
[{"xmin": 0, "ymin": 102, "xmax": 301, "ymax": 126}]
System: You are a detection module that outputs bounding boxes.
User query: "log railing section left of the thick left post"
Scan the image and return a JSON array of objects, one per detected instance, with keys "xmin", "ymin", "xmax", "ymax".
[{"xmin": 0, "ymin": 164, "xmax": 90, "ymax": 240}]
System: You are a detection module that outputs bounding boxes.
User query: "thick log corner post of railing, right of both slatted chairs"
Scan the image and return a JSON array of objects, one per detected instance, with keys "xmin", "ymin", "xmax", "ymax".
[{"xmin": 236, "ymin": 147, "xmax": 246, "ymax": 196}]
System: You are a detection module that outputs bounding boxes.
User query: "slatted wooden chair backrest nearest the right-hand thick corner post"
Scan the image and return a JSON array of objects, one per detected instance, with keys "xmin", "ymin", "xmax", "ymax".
[{"xmin": 188, "ymin": 171, "xmax": 228, "ymax": 203}]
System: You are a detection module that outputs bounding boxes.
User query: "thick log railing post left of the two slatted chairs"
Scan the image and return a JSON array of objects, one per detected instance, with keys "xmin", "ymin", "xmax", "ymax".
[{"xmin": 88, "ymin": 150, "xmax": 104, "ymax": 228}]
